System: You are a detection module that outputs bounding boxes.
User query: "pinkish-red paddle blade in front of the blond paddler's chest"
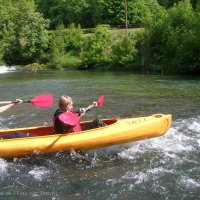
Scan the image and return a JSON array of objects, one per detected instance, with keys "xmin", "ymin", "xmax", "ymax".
[{"xmin": 58, "ymin": 112, "xmax": 80, "ymax": 126}]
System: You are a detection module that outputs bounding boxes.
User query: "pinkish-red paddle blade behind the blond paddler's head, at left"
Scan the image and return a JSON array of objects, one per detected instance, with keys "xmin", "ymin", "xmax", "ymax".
[{"xmin": 31, "ymin": 94, "xmax": 53, "ymax": 107}]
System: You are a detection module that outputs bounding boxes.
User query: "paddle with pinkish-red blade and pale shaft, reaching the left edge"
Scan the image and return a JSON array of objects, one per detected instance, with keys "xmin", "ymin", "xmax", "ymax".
[{"xmin": 0, "ymin": 94, "xmax": 53, "ymax": 108}]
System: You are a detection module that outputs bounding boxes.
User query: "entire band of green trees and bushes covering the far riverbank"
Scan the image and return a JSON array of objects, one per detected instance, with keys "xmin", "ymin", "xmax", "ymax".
[{"xmin": 0, "ymin": 0, "xmax": 200, "ymax": 74}]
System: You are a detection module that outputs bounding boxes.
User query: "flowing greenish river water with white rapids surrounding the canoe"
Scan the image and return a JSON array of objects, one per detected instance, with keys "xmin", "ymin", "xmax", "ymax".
[{"xmin": 0, "ymin": 71, "xmax": 200, "ymax": 200}]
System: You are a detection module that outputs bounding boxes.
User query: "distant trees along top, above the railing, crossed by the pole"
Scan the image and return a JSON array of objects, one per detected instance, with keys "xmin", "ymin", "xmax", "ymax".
[{"xmin": 36, "ymin": 0, "xmax": 164, "ymax": 29}]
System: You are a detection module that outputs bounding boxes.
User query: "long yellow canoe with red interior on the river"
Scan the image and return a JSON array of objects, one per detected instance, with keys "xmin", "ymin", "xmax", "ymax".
[{"xmin": 0, "ymin": 114, "xmax": 172, "ymax": 158}]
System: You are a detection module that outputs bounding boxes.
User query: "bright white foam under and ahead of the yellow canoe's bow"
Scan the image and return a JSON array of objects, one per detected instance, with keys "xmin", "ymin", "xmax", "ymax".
[{"xmin": 118, "ymin": 116, "xmax": 200, "ymax": 160}]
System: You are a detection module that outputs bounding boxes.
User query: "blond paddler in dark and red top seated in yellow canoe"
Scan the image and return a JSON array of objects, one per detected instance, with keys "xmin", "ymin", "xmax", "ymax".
[{"xmin": 52, "ymin": 95, "xmax": 106, "ymax": 133}]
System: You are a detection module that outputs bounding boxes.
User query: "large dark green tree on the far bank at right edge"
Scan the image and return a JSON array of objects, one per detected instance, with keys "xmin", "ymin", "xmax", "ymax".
[{"xmin": 143, "ymin": 0, "xmax": 200, "ymax": 73}]
